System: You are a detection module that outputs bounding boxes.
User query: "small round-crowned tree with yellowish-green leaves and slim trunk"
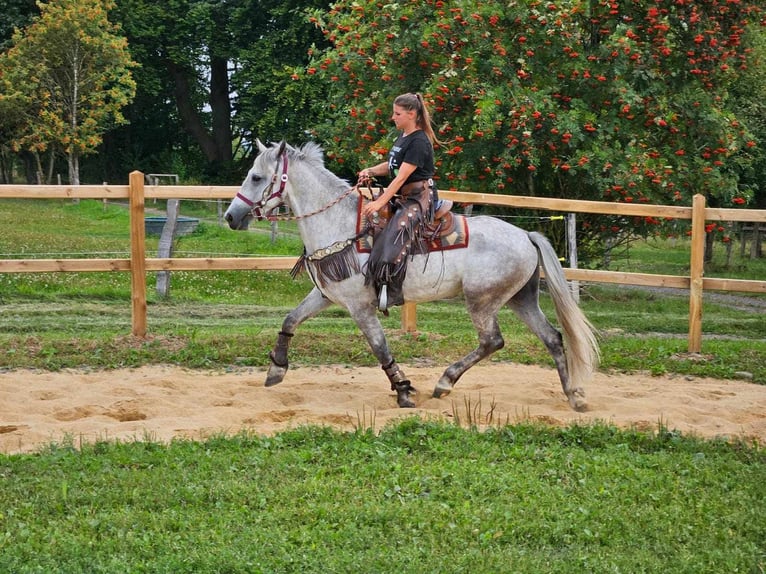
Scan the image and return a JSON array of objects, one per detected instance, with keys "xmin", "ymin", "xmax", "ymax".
[{"xmin": 0, "ymin": 0, "xmax": 135, "ymax": 185}]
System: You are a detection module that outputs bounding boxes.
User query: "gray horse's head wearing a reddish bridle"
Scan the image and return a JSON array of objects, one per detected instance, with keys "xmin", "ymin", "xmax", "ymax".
[{"xmin": 224, "ymin": 141, "xmax": 288, "ymax": 229}]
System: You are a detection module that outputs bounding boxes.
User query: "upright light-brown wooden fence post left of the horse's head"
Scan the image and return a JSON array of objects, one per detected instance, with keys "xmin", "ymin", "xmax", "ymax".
[{"xmin": 128, "ymin": 171, "xmax": 146, "ymax": 338}]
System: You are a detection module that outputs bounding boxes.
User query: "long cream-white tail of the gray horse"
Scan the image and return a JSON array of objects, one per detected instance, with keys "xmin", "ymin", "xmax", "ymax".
[{"xmin": 529, "ymin": 231, "xmax": 601, "ymax": 389}]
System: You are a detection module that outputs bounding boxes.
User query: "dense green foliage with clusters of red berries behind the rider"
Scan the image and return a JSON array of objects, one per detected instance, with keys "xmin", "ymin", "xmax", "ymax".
[{"xmin": 300, "ymin": 0, "xmax": 764, "ymax": 254}]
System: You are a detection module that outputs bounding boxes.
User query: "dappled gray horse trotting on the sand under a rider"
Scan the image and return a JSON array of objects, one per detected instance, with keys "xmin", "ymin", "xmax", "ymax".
[{"xmin": 225, "ymin": 142, "xmax": 599, "ymax": 410}]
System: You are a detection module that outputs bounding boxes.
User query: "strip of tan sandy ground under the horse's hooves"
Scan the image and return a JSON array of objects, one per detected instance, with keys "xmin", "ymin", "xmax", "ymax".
[{"xmin": 0, "ymin": 364, "xmax": 766, "ymax": 454}]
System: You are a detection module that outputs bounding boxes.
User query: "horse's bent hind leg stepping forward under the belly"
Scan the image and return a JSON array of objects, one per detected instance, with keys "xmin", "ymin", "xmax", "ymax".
[{"xmin": 433, "ymin": 301, "xmax": 505, "ymax": 399}]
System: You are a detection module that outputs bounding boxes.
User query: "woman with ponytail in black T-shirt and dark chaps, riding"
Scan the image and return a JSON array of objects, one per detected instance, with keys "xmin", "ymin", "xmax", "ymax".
[{"xmin": 358, "ymin": 93, "xmax": 438, "ymax": 312}]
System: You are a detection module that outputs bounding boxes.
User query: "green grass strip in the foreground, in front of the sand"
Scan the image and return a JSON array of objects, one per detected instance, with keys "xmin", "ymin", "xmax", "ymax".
[{"xmin": 0, "ymin": 418, "xmax": 766, "ymax": 574}]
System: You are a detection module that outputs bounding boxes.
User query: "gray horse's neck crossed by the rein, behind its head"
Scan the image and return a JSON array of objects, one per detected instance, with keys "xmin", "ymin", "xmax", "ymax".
[{"xmin": 292, "ymin": 170, "xmax": 357, "ymax": 253}]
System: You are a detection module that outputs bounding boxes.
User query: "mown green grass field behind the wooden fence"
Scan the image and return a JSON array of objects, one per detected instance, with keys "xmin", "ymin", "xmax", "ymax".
[{"xmin": 0, "ymin": 200, "xmax": 766, "ymax": 383}]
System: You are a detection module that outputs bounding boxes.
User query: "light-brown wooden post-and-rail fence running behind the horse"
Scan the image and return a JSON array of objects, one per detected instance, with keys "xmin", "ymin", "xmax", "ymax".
[{"xmin": 0, "ymin": 171, "xmax": 766, "ymax": 353}]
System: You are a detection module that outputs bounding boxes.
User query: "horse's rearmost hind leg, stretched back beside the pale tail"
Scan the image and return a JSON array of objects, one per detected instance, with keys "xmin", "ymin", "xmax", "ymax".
[{"xmin": 508, "ymin": 273, "xmax": 588, "ymax": 411}]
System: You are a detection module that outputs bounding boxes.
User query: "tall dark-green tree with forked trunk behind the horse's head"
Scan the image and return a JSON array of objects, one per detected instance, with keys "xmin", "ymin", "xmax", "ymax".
[{"xmin": 111, "ymin": 0, "xmax": 328, "ymax": 183}]
